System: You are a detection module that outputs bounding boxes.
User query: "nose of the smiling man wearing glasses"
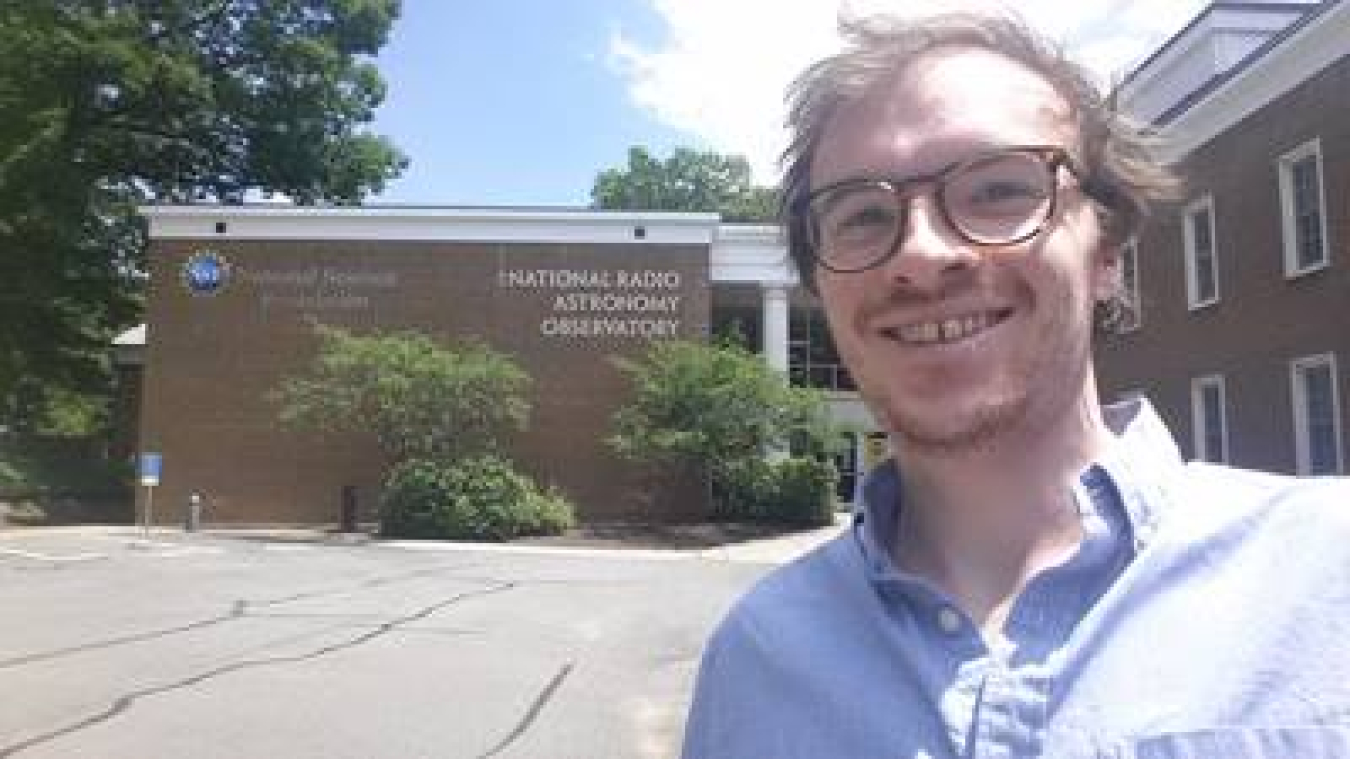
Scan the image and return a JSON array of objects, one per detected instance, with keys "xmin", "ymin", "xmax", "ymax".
[{"xmin": 884, "ymin": 194, "xmax": 980, "ymax": 292}]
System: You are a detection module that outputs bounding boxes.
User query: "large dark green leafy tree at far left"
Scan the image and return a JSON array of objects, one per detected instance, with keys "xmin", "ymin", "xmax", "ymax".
[{"xmin": 0, "ymin": 0, "xmax": 406, "ymax": 428}]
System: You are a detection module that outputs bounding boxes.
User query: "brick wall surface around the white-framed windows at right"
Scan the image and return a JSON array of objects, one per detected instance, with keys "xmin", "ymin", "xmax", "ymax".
[{"xmin": 1098, "ymin": 47, "xmax": 1350, "ymax": 473}]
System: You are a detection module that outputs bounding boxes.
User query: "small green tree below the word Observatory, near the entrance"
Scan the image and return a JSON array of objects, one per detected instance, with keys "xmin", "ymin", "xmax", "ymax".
[{"xmin": 609, "ymin": 340, "xmax": 838, "ymax": 516}]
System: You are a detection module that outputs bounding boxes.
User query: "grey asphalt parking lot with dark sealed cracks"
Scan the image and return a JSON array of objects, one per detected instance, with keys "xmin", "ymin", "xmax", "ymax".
[{"xmin": 0, "ymin": 528, "xmax": 824, "ymax": 759}]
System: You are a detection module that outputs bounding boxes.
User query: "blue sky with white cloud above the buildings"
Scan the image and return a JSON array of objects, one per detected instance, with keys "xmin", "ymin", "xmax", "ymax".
[{"xmin": 370, "ymin": 0, "xmax": 1207, "ymax": 207}]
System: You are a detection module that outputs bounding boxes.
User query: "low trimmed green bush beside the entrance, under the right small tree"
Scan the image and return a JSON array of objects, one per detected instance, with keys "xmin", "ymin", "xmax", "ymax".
[{"xmin": 713, "ymin": 458, "xmax": 838, "ymax": 527}]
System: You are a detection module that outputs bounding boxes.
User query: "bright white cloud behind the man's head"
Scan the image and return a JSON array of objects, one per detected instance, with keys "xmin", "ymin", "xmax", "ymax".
[{"xmin": 609, "ymin": 0, "xmax": 1207, "ymax": 182}]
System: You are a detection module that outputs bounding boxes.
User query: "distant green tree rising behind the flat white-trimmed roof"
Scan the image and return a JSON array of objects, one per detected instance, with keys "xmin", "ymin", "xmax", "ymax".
[{"xmin": 591, "ymin": 146, "xmax": 778, "ymax": 221}]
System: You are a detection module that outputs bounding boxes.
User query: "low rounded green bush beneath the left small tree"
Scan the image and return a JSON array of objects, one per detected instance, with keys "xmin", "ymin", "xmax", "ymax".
[{"xmin": 381, "ymin": 454, "xmax": 575, "ymax": 540}]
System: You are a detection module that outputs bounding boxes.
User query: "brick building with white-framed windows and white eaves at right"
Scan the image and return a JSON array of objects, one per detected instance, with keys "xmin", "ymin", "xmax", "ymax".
[{"xmin": 1098, "ymin": 0, "xmax": 1350, "ymax": 474}]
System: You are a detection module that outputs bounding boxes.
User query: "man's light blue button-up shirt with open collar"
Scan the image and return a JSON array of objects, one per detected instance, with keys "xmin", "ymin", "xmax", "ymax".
[{"xmin": 684, "ymin": 400, "xmax": 1350, "ymax": 759}]
